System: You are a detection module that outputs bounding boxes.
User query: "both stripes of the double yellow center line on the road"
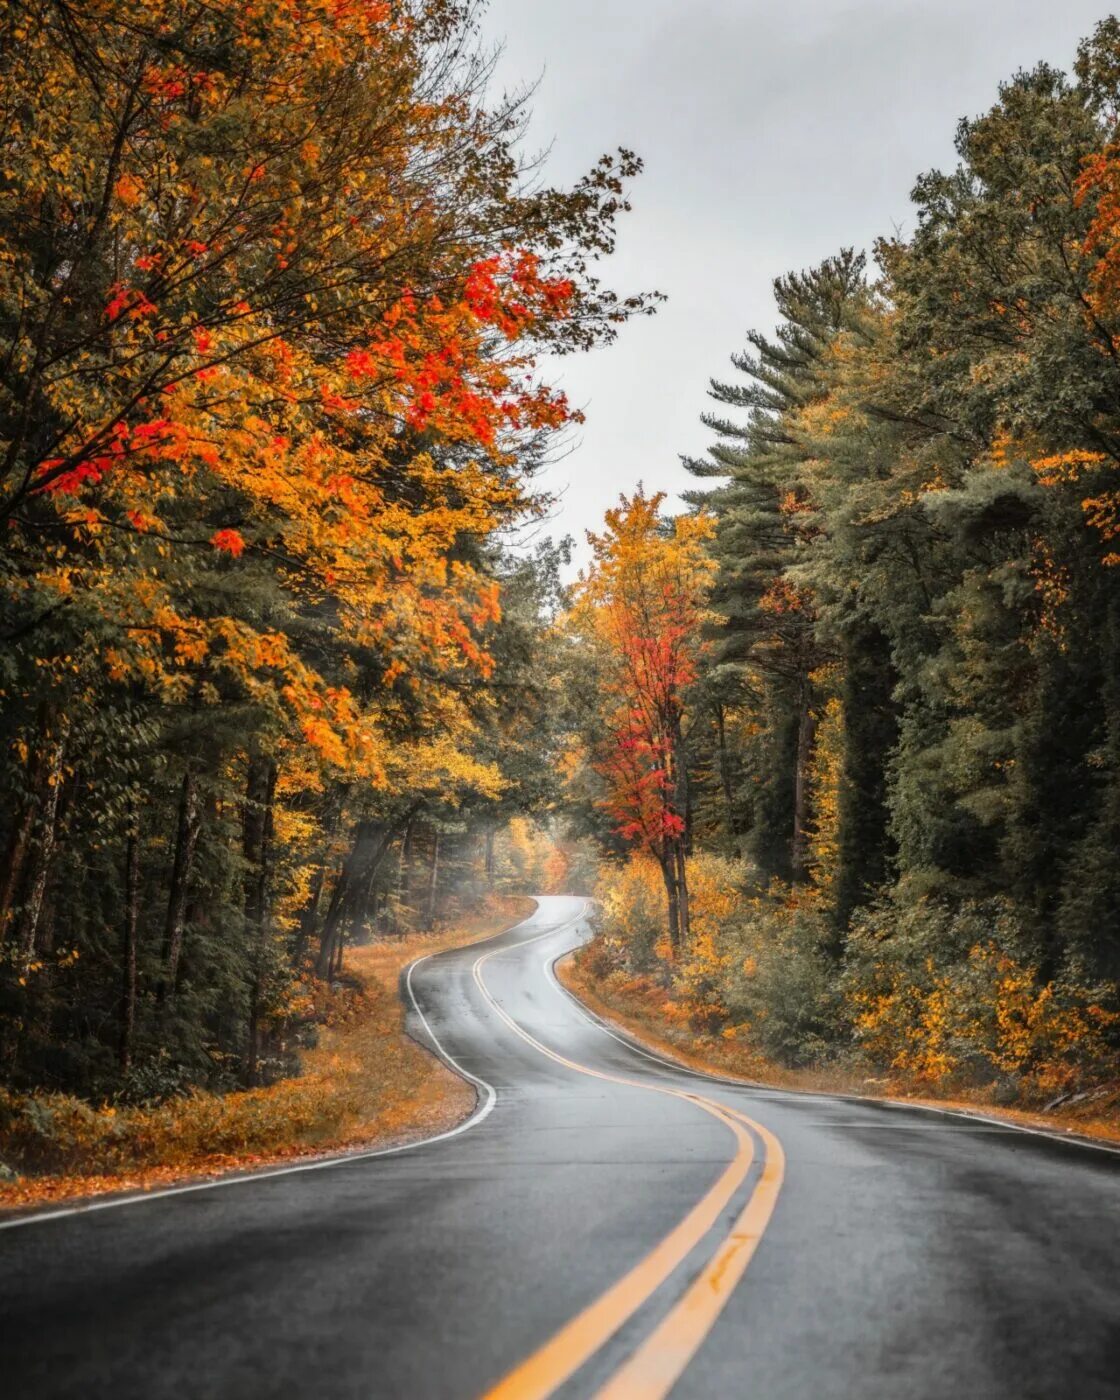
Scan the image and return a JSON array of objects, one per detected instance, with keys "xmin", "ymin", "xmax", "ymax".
[{"xmin": 472, "ymin": 930, "xmax": 785, "ymax": 1400}]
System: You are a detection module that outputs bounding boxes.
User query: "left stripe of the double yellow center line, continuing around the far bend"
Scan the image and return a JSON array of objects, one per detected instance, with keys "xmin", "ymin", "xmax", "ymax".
[{"xmin": 472, "ymin": 930, "xmax": 781, "ymax": 1400}]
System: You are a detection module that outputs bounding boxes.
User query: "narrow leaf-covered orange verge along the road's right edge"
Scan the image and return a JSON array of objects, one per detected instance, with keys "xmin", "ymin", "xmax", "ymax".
[{"xmin": 556, "ymin": 949, "xmax": 1120, "ymax": 1142}]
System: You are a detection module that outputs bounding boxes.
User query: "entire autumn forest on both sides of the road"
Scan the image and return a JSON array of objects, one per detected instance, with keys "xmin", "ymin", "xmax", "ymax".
[{"xmin": 0, "ymin": 0, "xmax": 1120, "ymax": 1164}]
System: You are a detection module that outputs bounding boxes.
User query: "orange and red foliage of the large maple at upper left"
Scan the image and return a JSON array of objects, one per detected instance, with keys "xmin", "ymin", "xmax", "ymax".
[{"xmin": 0, "ymin": 0, "xmax": 652, "ymax": 777}]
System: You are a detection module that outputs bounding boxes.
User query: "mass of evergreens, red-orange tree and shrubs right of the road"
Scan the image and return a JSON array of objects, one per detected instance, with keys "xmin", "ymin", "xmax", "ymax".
[{"xmin": 568, "ymin": 20, "xmax": 1120, "ymax": 1102}]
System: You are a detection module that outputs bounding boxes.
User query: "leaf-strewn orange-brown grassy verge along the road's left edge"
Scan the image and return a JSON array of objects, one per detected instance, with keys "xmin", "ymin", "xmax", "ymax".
[{"xmin": 0, "ymin": 896, "xmax": 533, "ymax": 1210}]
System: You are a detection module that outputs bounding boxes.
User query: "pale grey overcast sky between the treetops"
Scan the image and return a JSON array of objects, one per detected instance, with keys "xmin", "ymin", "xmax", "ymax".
[{"xmin": 484, "ymin": 0, "xmax": 1109, "ymax": 562}]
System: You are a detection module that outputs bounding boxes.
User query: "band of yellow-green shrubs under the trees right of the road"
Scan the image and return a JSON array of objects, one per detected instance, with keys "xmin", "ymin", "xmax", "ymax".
[{"xmin": 582, "ymin": 855, "xmax": 1120, "ymax": 1102}]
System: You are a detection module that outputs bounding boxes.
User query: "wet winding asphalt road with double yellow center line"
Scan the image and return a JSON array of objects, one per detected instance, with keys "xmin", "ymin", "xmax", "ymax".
[{"xmin": 0, "ymin": 897, "xmax": 1120, "ymax": 1400}]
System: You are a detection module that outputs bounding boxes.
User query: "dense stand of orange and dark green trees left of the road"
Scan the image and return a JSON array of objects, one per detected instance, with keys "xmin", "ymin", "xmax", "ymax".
[{"xmin": 0, "ymin": 0, "xmax": 654, "ymax": 1117}]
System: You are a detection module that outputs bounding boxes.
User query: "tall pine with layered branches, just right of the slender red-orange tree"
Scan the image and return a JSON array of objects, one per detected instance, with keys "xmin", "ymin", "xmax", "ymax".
[{"xmin": 686, "ymin": 251, "xmax": 864, "ymax": 879}]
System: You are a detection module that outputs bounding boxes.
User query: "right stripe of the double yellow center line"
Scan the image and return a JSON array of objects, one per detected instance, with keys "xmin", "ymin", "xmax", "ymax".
[{"xmin": 595, "ymin": 1113, "xmax": 785, "ymax": 1400}]
